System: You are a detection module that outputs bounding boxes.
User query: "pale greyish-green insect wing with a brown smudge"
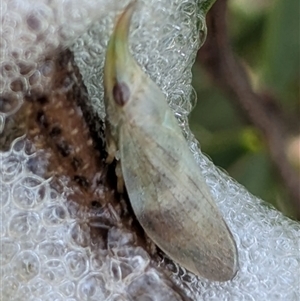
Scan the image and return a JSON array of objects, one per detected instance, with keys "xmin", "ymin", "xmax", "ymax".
[{"xmin": 119, "ymin": 104, "xmax": 237, "ymax": 281}]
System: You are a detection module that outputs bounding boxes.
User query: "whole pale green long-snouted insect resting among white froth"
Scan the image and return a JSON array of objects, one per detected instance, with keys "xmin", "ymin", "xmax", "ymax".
[{"xmin": 104, "ymin": 2, "xmax": 238, "ymax": 281}]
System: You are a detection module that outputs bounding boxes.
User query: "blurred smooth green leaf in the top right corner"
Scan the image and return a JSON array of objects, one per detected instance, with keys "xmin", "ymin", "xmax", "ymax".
[{"xmin": 262, "ymin": 0, "xmax": 300, "ymax": 107}]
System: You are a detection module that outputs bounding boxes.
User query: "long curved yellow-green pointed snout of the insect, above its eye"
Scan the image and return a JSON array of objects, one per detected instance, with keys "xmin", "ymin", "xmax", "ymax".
[{"xmin": 104, "ymin": 1, "xmax": 136, "ymax": 95}]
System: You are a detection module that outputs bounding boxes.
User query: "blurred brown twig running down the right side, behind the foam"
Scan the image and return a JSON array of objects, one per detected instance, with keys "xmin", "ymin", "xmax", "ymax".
[{"xmin": 197, "ymin": 0, "xmax": 300, "ymax": 219}]
